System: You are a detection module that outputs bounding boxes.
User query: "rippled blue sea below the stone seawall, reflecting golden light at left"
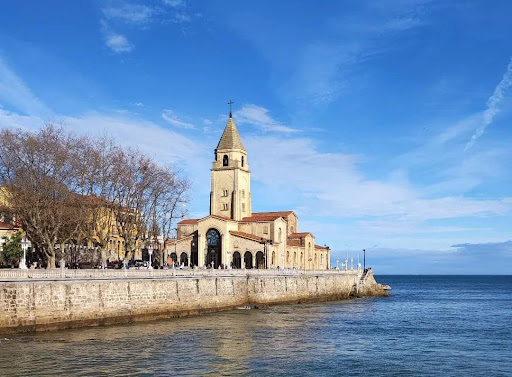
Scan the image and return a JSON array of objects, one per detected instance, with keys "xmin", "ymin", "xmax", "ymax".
[{"xmin": 0, "ymin": 276, "xmax": 512, "ymax": 377}]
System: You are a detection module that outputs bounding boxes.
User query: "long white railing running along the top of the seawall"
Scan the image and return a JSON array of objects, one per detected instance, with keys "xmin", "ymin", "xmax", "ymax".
[{"xmin": 0, "ymin": 269, "xmax": 357, "ymax": 282}]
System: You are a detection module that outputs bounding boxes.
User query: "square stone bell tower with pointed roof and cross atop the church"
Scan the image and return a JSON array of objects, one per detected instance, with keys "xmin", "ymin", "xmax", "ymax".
[{"xmin": 210, "ymin": 101, "xmax": 252, "ymax": 221}]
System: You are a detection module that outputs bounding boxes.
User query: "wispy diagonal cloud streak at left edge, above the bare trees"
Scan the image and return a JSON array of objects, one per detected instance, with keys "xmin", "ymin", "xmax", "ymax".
[{"xmin": 0, "ymin": 58, "xmax": 51, "ymax": 116}]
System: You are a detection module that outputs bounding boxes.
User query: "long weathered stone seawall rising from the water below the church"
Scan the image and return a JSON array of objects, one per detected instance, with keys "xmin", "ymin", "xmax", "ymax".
[{"xmin": 0, "ymin": 273, "xmax": 385, "ymax": 333}]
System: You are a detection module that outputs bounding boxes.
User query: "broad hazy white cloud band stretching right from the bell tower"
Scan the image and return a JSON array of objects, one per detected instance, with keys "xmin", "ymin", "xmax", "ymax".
[{"xmin": 244, "ymin": 137, "xmax": 512, "ymax": 224}]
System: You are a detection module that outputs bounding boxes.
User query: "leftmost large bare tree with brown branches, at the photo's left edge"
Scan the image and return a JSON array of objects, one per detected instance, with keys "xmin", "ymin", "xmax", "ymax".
[{"xmin": 0, "ymin": 126, "xmax": 76, "ymax": 268}]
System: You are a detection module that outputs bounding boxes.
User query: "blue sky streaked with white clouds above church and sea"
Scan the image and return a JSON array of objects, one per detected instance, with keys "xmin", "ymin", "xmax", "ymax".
[{"xmin": 0, "ymin": 0, "xmax": 512, "ymax": 274}]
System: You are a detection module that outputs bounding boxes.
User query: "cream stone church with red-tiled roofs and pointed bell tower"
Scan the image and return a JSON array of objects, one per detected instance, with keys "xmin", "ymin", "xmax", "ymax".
[{"xmin": 166, "ymin": 107, "xmax": 330, "ymax": 270}]
